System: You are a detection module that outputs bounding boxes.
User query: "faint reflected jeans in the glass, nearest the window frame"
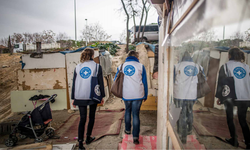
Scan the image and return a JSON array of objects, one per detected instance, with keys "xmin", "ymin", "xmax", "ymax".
[{"xmin": 174, "ymin": 100, "xmax": 195, "ymax": 143}]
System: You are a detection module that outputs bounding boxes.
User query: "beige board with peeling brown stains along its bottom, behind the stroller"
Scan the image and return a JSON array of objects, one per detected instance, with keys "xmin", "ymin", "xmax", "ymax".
[{"xmin": 18, "ymin": 68, "xmax": 67, "ymax": 91}]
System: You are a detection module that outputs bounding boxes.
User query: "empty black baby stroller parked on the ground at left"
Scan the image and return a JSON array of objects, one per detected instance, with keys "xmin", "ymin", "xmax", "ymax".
[{"xmin": 5, "ymin": 94, "xmax": 57, "ymax": 147}]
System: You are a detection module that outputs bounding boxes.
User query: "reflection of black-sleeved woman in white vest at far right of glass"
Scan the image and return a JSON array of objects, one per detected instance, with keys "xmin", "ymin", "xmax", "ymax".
[{"xmin": 216, "ymin": 48, "xmax": 250, "ymax": 149}]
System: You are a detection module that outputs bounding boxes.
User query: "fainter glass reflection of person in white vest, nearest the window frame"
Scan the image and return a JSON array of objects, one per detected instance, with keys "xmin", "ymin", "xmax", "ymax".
[{"xmin": 174, "ymin": 51, "xmax": 205, "ymax": 144}]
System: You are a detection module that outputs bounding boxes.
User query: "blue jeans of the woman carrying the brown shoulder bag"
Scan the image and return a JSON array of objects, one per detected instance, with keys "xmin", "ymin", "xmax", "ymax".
[{"xmin": 124, "ymin": 100, "xmax": 142, "ymax": 139}]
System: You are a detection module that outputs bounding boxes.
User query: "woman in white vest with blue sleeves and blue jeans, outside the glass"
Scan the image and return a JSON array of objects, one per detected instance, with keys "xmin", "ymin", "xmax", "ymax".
[{"xmin": 114, "ymin": 51, "xmax": 148, "ymax": 144}]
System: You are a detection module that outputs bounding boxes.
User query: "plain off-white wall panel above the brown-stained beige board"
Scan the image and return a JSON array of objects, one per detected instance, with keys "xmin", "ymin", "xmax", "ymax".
[{"xmin": 22, "ymin": 53, "xmax": 65, "ymax": 69}]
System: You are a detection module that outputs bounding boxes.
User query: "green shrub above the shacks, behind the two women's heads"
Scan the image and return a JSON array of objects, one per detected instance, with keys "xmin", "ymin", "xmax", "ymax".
[{"xmin": 91, "ymin": 42, "xmax": 121, "ymax": 55}]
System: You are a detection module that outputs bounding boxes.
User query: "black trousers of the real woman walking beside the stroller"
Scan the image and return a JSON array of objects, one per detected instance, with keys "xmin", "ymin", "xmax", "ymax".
[{"xmin": 78, "ymin": 104, "xmax": 97, "ymax": 142}]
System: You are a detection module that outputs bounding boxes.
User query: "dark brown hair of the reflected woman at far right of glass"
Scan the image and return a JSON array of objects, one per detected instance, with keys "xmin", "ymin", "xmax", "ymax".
[{"xmin": 228, "ymin": 47, "xmax": 245, "ymax": 62}]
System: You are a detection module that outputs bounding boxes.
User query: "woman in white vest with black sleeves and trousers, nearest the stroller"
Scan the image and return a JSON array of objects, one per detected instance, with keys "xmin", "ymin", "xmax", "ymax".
[{"xmin": 71, "ymin": 48, "xmax": 105, "ymax": 150}]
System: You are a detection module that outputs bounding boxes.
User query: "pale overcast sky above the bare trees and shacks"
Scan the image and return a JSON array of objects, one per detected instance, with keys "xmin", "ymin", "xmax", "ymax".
[{"xmin": 0, "ymin": 0, "xmax": 158, "ymax": 40}]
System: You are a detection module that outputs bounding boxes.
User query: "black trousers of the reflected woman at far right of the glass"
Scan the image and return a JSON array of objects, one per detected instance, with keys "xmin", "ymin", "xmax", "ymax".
[{"xmin": 224, "ymin": 101, "xmax": 250, "ymax": 144}]
